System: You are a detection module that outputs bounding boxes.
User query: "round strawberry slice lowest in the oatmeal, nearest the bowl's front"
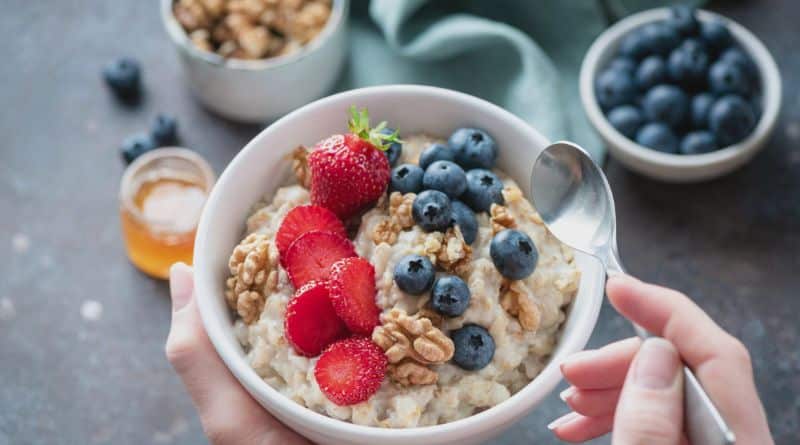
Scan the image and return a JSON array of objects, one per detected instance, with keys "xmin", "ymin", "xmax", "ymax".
[{"xmin": 314, "ymin": 337, "xmax": 387, "ymax": 406}]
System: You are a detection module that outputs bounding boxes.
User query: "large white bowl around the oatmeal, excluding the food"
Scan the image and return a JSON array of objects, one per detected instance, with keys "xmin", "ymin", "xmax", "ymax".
[{"xmin": 194, "ymin": 85, "xmax": 605, "ymax": 445}]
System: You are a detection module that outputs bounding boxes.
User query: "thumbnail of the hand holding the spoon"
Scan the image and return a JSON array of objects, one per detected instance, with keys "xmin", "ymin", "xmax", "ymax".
[{"xmin": 633, "ymin": 338, "xmax": 680, "ymax": 389}]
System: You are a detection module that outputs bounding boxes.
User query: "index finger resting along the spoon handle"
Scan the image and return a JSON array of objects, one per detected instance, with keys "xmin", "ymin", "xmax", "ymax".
[{"xmin": 607, "ymin": 276, "xmax": 770, "ymax": 443}]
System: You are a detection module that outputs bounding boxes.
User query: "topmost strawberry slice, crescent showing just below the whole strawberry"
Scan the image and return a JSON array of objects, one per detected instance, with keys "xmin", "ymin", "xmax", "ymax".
[{"xmin": 275, "ymin": 205, "xmax": 347, "ymax": 260}]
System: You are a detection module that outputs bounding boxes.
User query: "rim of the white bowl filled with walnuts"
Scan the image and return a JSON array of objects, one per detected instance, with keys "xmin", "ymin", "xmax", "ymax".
[{"xmin": 161, "ymin": 0, "xmax": 350, "ymax": 71}]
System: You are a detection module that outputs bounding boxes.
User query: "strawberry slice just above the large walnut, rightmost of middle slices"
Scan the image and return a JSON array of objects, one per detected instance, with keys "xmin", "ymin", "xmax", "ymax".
[{"xmin": 328, "ymin": 257, "xmax": 381, "ymax": 336}]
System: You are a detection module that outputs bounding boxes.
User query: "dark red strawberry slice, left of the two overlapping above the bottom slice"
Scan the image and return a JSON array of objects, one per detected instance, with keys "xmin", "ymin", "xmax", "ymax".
[{"xmin": 283, "ymin": 281, "xmax": 348, "ymax": 357}]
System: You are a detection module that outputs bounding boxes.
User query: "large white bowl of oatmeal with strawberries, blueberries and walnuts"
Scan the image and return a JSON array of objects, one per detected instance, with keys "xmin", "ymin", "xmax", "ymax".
[{"xmin": 194, "ymin": 85, "xmax": 605, "ymax": 444}]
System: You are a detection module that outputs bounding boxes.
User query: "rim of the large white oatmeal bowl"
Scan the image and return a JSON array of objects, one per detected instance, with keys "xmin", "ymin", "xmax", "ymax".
[{"xmin": 195, "ymin": 85, "xmax": 605, "ymax": 441}]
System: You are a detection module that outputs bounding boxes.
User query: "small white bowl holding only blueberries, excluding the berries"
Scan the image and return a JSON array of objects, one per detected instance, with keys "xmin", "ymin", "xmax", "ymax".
[{"xmin": 580, "ymin": 8, "xmax": 781, "ymax": 182}]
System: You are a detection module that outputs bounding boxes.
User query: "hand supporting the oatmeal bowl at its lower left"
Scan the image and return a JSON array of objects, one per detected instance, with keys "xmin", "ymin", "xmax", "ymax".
[{"xmin": 166, "ymin": 263, "xmax": 306, "ymax": 444}]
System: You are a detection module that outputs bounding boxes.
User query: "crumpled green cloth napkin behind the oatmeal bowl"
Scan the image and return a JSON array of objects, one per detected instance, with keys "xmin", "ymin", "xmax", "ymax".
[{"xmin": 338, "ymin": 0, "xmax": 699, "ymax": 161}]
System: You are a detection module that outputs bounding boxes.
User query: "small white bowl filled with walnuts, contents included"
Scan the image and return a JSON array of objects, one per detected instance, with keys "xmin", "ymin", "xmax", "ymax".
[{"xmin": 161, "ymin": 0, "xmax": 349, "ymax": 122}]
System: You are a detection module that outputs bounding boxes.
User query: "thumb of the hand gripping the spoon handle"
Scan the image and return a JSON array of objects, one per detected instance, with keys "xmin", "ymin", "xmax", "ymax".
[{"xmin": 612, "ymin": 338, "xmax": 683, "ymax": 445}]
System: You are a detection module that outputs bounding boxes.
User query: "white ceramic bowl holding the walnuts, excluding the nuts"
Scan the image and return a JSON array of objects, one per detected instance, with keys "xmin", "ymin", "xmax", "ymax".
[{"xmin": 161, "ymin": 0, "xmax": 350, "ymax": 123}]
